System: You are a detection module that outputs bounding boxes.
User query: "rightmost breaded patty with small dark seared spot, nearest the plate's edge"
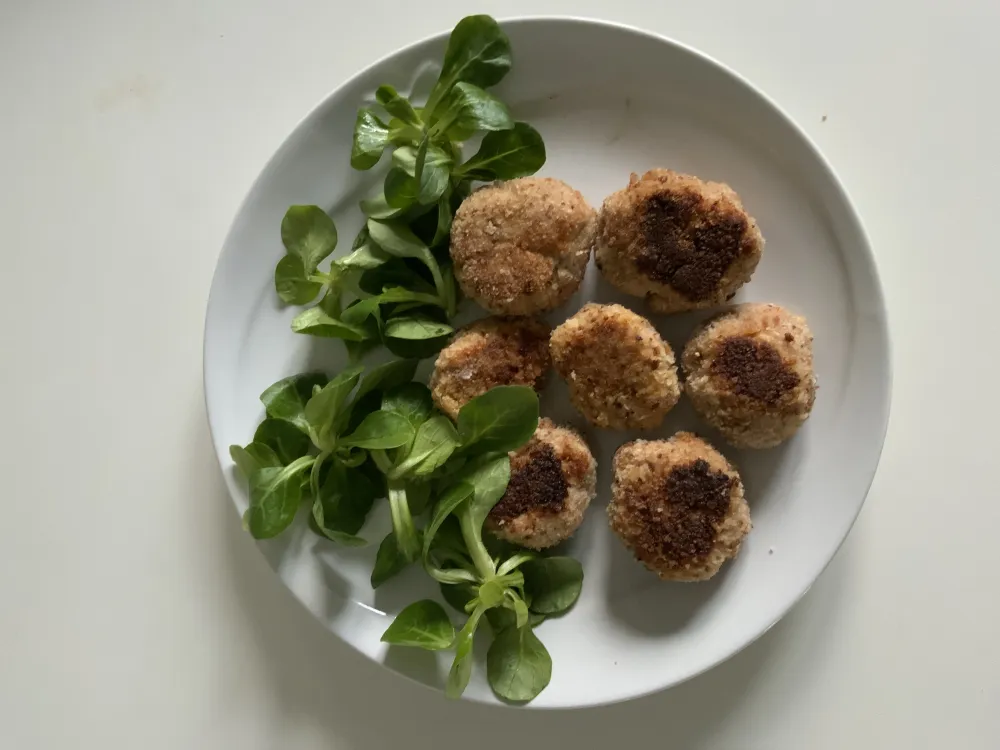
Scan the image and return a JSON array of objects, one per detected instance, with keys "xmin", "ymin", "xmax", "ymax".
[{"xmin": 683, "ymin": 304, "xmax": 816, "ymax": 448}]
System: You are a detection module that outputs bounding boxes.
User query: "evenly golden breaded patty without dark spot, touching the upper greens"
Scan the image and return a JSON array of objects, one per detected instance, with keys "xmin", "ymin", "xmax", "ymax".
[{"xmin": 451, "ymin": 177, "xmax": 597, "ymax": 315}]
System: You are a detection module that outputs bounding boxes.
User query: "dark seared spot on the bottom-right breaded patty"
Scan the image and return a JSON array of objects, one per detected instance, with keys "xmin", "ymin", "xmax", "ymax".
[{"xmin": 634, "ymin": 458, "xmax": 734, "ymax": 567}]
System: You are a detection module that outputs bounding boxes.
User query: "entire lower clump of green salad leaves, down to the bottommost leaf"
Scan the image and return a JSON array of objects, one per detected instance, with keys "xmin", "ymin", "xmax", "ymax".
[{"xmin": 230, "ymin": 368, "xmax": 583, "ymax": 701}]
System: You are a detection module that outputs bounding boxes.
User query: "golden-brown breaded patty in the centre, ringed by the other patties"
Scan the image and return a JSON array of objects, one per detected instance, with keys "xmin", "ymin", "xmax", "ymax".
[{"xmin": 549, "ymin": 304, "xmax": 680, "ymax": 430}]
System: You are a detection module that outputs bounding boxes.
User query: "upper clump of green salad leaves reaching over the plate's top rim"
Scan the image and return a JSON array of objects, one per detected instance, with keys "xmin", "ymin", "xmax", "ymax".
[{"xmin": 274, "ymin": 11, "xmax": 545, "ymax": 360}]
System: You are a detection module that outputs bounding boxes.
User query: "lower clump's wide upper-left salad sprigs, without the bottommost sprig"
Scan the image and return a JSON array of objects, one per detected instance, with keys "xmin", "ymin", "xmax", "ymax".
[{"xmin": 229, "ymin": 360, "xmax": 538, "ymax": 568}]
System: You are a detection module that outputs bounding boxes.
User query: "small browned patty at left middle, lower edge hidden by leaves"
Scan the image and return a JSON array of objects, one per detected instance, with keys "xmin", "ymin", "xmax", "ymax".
[{"xmin": 430, "ymin": 317, "xmax": 552, "ymax": 419}]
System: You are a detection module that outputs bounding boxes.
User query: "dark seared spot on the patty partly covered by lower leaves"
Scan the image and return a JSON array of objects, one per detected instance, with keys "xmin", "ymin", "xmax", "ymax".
[{"xmin": 490, "ymin": 441, "xmax": 569, "ymax": 526}]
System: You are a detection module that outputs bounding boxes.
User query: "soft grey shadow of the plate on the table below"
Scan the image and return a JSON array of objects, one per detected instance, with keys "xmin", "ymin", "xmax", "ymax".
[{"xmin": 199, "ymin": 414, "xmax": 851, "ymax": 750}]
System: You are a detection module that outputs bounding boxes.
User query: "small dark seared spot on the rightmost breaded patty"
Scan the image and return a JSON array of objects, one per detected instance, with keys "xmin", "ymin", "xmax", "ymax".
[{"xmin": 712, "ymin": 336, "xmax": 799, "ymax": 406}]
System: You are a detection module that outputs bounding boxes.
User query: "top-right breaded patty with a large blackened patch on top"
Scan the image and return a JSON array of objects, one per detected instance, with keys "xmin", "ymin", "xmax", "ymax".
[{"xmin": 595, "ymin": 169, "xmax": 764, "ymax": 313}]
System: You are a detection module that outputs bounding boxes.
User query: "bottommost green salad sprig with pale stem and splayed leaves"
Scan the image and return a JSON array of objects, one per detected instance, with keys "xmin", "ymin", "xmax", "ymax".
[{"xmin": 382, "ymin": 476, "xmax": 583, "ymax": 702}]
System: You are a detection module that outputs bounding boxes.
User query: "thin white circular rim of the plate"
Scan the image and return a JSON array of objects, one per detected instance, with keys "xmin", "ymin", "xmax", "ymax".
[{"xmin": 202, "ymin": 14, "xmax": 893, "ymax": 710}]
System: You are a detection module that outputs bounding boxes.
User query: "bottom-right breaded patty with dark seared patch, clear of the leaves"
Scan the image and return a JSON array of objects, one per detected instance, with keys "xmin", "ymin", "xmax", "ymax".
[{"xmin": 608, "ymin": 432, "xmax": 751, "ymax": 581}]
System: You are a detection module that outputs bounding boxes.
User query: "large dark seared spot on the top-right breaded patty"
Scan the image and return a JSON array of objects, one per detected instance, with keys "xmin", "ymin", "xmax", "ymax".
[{"xmin": 635, "ymin": 191, "xmax": 747, "ymax": 301}]
